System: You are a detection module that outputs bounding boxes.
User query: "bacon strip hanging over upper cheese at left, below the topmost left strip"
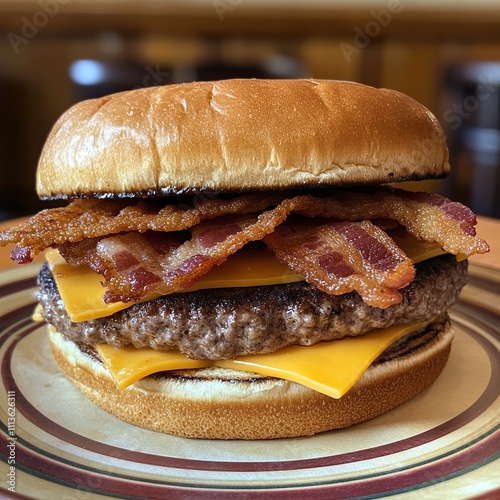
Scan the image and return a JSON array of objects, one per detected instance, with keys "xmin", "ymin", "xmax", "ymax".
[{"xmin": 96, "ymin": 201, "xmax": 288, "ymax": 302}]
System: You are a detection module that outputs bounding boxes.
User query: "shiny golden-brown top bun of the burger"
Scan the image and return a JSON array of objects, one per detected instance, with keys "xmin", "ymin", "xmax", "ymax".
[{"xmin": 37, "ymin": 80, "xmax": 449, "ymax": 199}]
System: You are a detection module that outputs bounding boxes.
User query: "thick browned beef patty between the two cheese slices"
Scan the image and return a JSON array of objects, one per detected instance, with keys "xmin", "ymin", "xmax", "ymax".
[{"xmin": 38, "ymin": 255, "xmax": 467, "ymax": 359}]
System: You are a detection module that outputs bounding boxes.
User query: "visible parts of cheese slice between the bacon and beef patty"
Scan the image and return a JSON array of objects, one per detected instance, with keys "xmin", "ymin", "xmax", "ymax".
[{"xmin": 46, "ymin": 237, "xmax": 444, "ymax": 322}]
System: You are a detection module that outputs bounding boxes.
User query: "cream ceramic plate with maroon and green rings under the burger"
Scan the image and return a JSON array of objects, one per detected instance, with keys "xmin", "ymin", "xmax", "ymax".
[{"xmin": 0, "ymin": 265, "xmax": 500, "ymax": 500}]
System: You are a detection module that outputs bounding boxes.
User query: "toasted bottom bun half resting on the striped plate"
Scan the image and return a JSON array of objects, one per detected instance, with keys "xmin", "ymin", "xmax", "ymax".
[{"xmin": 49, "ymin": 325, "xmax": 453, "ymax": 439}]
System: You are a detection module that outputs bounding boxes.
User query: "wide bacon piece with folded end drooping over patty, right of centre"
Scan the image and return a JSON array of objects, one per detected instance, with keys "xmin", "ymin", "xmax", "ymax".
[{"xmin": 264, "ymin": 216, "xmax": 415, "ymax": 308}]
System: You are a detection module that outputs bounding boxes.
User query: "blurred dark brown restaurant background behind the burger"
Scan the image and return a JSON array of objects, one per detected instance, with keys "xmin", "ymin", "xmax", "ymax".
[{"xmin": 0, "ymin": 0, "xmax": 500, "ymax": 218}]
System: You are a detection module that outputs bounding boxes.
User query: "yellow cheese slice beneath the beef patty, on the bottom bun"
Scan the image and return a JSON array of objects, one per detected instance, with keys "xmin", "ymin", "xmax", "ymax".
[{"xmin": 95, "ymin": 322, "xmax": 429, "ymax": 398}]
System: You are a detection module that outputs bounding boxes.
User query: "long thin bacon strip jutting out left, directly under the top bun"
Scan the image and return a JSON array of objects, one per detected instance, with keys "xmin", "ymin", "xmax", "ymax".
[{"xmin": 0, "ymin": 193, "xmax": 285, "ymax": 264}]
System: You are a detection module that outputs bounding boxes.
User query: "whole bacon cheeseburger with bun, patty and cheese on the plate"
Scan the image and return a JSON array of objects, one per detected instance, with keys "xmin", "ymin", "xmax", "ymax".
[{"xmin": 0, "ymin": 80, "xmax": 488, "ymax": 439}]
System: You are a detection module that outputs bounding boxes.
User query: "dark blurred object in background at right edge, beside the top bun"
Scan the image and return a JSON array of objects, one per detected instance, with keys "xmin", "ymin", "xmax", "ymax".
[{"xmin": 443, "ymin": 62, "xmax": 500, "ymax": 217}]
